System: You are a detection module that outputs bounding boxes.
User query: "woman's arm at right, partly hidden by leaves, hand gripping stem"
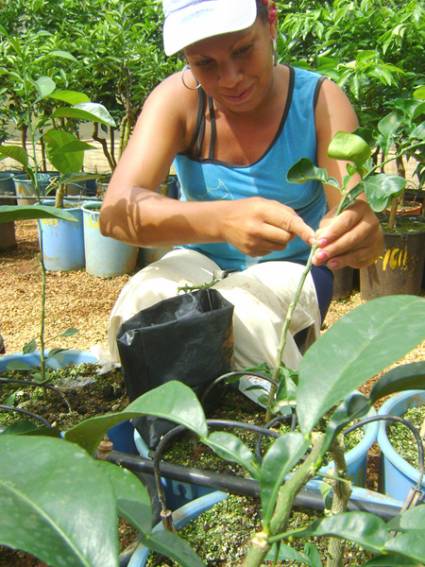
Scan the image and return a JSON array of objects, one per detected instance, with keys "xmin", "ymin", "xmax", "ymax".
[{"xmin": 314, "ymin": 80, "xmax": 383, "ymax": 269}]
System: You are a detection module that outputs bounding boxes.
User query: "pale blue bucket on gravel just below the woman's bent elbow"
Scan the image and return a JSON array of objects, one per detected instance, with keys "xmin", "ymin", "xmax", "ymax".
[{"xmin": 83, "ymin": 202, "xmax": 139, "ymax": 278}]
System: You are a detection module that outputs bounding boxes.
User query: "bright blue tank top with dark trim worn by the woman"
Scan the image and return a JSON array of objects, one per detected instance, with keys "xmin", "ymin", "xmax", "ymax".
[{"xmin": 174, "ymin": 68, "xmax": 327, "ymax": 270}]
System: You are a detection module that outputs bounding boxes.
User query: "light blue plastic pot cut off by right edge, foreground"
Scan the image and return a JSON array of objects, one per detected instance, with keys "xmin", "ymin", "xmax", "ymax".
[{"xmin": 378, "ymin": 390, "xmax": 425, "ymax": 501}]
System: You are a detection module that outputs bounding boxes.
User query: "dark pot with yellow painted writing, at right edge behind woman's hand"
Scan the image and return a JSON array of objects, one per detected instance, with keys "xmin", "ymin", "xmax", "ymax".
[{"xmin": 360, "ymin": 217, "xmax": 425, "ymax": 300}]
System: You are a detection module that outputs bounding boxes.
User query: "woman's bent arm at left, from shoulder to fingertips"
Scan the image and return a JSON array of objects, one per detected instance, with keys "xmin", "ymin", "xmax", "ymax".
[{"xmin": 100, "ymin": 74, "xmax": 313, "ymax": 256}]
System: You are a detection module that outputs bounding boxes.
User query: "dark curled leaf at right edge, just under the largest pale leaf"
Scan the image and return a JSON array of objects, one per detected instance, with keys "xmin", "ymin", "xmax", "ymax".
[{"xmin": 369, "ymin": 362, "xmax": 425, "ymax": 404}]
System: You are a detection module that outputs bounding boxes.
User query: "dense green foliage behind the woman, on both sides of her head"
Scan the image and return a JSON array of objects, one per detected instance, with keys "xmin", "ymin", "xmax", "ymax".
[{"xmin": 0, "ymin": 0, "xmax": 425, "ymax": 167}]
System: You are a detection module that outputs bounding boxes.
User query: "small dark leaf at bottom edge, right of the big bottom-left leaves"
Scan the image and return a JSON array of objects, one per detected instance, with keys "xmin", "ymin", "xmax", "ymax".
[{"xmin": 140, "ymin": 530, "xmax": 205, "ymax": 567}]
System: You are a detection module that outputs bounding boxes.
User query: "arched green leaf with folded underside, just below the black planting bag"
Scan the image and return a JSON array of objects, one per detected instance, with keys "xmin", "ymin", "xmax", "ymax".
[{"xmin": 65, "ymin": 380, "xmax": 208, "ymax": 453}]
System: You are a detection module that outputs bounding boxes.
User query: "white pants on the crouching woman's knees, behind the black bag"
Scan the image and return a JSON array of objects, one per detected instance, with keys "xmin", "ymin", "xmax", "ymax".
[{"xmin": 109, "ymin": 248, "xmax": 320, "ymax": 370}]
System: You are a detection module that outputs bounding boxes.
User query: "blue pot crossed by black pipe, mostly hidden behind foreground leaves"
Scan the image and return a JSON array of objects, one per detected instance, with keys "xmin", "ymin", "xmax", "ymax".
[{"xmin": 134, "ymin": 402, "xmax": 378, "ymax": 510}]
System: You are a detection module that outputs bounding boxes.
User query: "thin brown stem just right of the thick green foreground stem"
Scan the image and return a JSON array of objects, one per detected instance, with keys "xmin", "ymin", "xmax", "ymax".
[{"xmin": 326, "ymin": 434, "xmax": 351, "ymax": 567}]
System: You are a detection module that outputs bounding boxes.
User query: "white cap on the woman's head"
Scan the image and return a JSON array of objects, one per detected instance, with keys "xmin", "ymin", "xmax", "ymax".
[{"xmin": 162, "ymin": 0, "xmax": 257, "ymax": 55}]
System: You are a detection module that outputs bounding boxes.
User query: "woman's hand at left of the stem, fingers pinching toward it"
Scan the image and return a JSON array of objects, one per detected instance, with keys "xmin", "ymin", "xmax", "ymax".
[{"xmin": 219, "ymin": 197, "xmax": 314, "ymax": 257}]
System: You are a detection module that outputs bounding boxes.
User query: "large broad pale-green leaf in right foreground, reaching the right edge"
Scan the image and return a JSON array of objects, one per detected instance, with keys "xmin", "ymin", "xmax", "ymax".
[{"xmin": 297, "ymin": 295, "xmax": 425, "ymax": 432}]
